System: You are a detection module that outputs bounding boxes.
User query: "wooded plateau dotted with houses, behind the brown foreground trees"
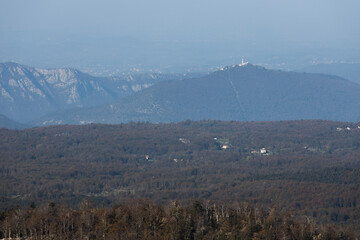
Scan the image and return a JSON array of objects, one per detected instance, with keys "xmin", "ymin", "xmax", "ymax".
[{"xmin": 0, "ymin": 121, "xmax": 360, "ymax": 239}]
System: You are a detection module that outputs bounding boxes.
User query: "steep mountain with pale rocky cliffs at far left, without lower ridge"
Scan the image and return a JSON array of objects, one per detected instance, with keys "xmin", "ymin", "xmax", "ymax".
[{"xmin": 0, "ymin": 63, "xmax": 117, "ymax": 121}]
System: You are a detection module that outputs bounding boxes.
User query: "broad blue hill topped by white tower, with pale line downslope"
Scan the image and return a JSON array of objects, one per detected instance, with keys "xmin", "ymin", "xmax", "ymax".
[{"xmin": 36, "ymin": 64, "xmax": 360, "ymax": 125}]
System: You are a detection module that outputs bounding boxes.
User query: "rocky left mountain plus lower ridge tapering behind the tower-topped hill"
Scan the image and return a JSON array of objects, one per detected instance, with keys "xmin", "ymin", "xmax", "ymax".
[{"xmin": 0, "ymin": 63, "xmax": 197, "ymax": 122}]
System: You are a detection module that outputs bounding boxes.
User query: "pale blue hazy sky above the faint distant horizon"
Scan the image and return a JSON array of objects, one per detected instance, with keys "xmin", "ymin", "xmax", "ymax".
[{"xmin": 0, "ymin": 0, "xmax": 360, "ymax": 71}]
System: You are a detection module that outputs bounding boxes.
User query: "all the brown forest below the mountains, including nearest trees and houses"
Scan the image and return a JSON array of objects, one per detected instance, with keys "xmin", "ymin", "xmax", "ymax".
[{"xmin": 0, "ymin": 121, "xmax": 360, "ymax": 239}]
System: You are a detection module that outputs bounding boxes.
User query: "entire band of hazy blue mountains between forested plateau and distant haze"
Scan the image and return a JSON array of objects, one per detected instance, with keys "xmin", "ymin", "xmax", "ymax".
[{"xmin": 0, "ymin": 63, "xmax": 360, "ymax": 126}]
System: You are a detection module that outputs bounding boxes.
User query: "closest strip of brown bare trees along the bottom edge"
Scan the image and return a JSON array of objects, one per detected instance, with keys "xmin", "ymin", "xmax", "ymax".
[{"xmin": 0, "ymin": 201, "xmax": 356, "ymax": 240}]
